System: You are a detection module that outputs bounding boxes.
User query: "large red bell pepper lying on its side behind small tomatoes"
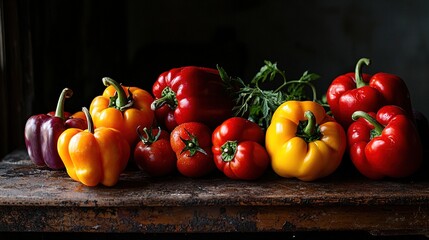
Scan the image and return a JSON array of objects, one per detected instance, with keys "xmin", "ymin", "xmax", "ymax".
[{"xmin": 151, "ymin": 66, "xmax": 234, "ymax": 131}]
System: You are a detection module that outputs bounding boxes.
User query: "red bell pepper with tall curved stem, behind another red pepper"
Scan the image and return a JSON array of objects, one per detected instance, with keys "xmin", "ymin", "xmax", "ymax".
[{"xmin": 326, "ymin": 58, "xmax": 412, "ymax": 130}]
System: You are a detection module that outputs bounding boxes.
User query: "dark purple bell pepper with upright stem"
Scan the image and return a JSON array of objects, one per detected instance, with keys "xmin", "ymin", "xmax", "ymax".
[{"xmin": 24, "ymin": 88, "xmax": 86, "ymax": 170}]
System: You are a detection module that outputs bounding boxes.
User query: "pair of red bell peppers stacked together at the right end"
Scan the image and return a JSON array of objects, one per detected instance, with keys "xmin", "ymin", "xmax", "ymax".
[{"xmin": 327, "ymin": 58, "xmax": 428, "ymax": 179}]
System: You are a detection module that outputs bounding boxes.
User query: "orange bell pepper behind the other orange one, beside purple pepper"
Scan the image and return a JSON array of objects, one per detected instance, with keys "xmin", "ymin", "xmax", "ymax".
[{"xmin": 89, "ymin": 77, "xmax": 155, "ymax": 146}]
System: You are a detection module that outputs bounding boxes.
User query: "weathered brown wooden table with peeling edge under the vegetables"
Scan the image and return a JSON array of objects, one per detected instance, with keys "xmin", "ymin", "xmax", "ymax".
[{"xmin": 0, "ymin": 151, "xmax": 429, "ymax": 234}]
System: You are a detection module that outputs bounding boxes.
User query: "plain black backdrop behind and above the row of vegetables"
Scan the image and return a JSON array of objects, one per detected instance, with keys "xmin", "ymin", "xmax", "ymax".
[{"xmin": 0, "ymin": 0, "xmax": 429, "ymax": 157}]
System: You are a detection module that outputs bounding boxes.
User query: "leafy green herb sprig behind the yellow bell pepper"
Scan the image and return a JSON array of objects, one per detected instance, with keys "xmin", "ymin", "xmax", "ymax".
[{"xmin": 217, "ymin": 60, "xmax": 322, "ymax": 129}]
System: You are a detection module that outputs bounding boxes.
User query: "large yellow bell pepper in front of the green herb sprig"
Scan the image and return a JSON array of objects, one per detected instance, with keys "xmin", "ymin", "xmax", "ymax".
[{"xmin": 265, "ymin": 101, "xmax": 346, "ymax": 181}]
